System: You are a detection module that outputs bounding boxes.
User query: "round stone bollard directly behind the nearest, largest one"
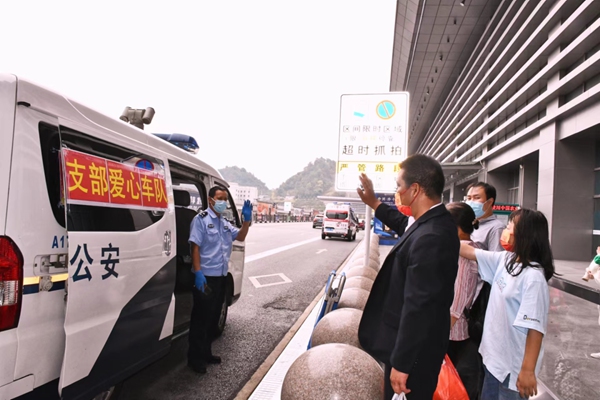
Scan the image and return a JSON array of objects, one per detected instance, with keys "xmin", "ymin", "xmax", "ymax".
[{"xmin": 310, "ymin": 308, "xmax": 362, "ymax": 349}]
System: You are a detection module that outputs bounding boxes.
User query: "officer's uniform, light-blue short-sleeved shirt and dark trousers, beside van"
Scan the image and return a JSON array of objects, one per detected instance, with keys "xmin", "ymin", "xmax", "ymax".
[{"xmin": 188, "ymin": 208, "xmax": 239, "ymax": 372}]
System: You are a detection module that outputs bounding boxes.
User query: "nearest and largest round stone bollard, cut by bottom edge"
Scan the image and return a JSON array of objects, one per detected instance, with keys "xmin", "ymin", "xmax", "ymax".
[{"xmin": 281, "ymin": 343, "xmax": 383, "ymax": 400}]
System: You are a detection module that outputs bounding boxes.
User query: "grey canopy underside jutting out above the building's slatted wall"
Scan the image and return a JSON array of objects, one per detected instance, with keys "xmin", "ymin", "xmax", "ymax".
[{"xmin": 390, "ymin": 0, "xmax": 501, "ymax": 154}]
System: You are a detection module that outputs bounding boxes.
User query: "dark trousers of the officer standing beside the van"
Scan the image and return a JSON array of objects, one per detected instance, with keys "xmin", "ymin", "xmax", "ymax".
[{"xmin": 188, "ymin": 276, "xmax": 226, "ymax": 368}]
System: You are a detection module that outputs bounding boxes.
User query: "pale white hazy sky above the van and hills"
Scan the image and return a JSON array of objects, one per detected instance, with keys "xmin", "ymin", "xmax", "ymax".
[{"xmin": 5, "ymin": 0, "xmax": 396, "ymax": 189}]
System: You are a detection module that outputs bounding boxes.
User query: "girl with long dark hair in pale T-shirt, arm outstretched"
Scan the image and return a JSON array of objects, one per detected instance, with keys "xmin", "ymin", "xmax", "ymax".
[{"xmin": 460, "ymin": 209, "xmax": 555, "ymax": 400}]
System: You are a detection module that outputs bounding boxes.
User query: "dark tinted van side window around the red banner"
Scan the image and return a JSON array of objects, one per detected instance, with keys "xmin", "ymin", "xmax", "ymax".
[{"xmin": 38, "ymin": 122, "xmax": 164, "ymax": 232}]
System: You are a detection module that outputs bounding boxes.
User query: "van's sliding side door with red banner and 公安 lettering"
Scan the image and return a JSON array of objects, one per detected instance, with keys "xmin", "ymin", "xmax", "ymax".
[{"xmin": 59, "ymin": 125, "xmax": 176, "ymax": 399}]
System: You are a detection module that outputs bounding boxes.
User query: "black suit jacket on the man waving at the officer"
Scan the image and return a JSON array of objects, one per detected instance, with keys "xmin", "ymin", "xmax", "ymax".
[{"xmin": 358, "ymin": 204, "xmax": 460, "ymax": 374}]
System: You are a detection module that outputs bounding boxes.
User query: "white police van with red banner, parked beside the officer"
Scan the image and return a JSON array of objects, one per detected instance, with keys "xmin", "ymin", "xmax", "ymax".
[{"xmin": 0, "ymin": 73, "xmax": 244, "ymax": 399}]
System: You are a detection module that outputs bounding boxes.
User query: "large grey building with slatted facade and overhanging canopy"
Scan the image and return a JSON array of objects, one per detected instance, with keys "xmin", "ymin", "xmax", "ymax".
[{"xmin": 390, "ymin": 0, "xmax": 600, "ymax": 261}]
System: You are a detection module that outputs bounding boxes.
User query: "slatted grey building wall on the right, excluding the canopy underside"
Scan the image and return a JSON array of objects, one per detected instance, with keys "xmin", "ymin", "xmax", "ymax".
[{"xmin": 410, "ymin": 1, "xmax": 600, "ymax": 261}]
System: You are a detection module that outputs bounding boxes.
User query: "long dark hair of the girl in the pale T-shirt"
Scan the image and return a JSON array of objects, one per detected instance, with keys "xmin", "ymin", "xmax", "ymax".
[{"xmin": 506, "ymin": 208, "xmax": 555, "ymax": 281}]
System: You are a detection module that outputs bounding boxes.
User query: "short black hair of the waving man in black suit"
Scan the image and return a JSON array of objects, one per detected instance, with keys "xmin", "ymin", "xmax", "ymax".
[{"xmin": 400, "ymin": 154, "xmax": 446, "ymax": 200}]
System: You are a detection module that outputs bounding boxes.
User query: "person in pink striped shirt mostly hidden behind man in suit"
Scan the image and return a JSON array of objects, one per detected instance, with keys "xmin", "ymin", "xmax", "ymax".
[{"xmin": 446, "ymin": 202, "xmax": 483, "ymax": 399}]
